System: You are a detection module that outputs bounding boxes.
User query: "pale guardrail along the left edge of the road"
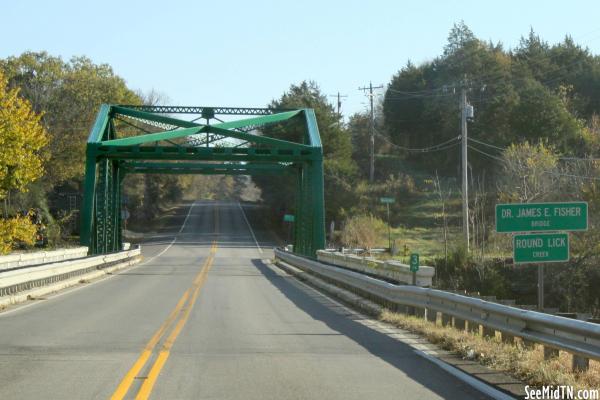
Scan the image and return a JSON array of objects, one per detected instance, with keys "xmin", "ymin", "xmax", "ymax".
[{"xmin": 0, "ymin": 246, "xmax": 141, "ymax": 297}]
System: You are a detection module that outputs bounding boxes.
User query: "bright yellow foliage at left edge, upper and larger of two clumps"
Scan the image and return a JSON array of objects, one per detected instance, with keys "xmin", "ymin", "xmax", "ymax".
[{"xmin": 0, "ymin": 71, "xmax": 48, "ymax": 198}]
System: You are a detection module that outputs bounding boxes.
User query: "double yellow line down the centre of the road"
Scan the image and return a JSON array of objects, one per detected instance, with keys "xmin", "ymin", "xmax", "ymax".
[{"xmin": 111, "ymin": 207, "xmax": 219, "ymax": 400}]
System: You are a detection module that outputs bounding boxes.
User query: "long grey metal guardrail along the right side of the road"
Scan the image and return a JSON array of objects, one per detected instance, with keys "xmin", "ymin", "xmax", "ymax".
[{"xmin": 274, "ymin": 249, "xmax": 600, "ymax": 365}]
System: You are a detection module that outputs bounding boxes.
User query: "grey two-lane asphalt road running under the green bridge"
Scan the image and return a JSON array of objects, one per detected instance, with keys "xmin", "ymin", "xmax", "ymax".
[{"xmin": 0, "ymin": 201, "xmax": 485, "ymax": 400}]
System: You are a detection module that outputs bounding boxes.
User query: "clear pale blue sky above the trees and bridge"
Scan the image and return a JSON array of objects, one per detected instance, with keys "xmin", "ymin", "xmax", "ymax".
[{"xmin": 0, "ymin": 0, "xmax": 600, "ymax": 115}]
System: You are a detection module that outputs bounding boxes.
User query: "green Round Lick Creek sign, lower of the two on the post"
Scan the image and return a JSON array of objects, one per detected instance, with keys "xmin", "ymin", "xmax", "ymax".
[{"xmin": 513, "ymin": 233, "xmax": 569, "ymax": 263}]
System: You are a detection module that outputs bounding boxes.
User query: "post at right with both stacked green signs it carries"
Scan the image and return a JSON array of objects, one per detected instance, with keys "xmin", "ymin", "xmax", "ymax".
[{"xmin": 496, "ymin": 201, "xmax": 588, "ymax": 311}]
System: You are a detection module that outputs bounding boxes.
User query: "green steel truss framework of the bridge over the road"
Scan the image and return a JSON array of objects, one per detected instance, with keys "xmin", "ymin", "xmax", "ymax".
[{"xmin": 81, "ymin": 104, "xmax": 325, "ymax": 256}]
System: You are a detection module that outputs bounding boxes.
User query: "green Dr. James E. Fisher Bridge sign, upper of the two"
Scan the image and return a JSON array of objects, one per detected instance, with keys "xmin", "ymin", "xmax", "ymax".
[{"xmin": 496, "ymin": 201, "xmax": 588, "ymax": 233}]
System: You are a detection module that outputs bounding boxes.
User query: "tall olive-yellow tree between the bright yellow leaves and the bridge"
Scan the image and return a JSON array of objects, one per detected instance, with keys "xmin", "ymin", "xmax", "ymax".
[{"xmin": 0, "ymin": 52, "xmax": 140, "ymax": 189}]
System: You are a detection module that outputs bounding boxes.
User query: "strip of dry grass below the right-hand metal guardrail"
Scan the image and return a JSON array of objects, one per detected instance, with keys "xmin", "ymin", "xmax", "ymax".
[{"xmin": 379, "ymin": 310, "xmax": 600, "ymax": 390}]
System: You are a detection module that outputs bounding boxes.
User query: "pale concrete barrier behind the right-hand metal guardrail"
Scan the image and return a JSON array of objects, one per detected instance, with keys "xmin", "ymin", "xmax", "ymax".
[{"xmin": 317, "ymin": 250, "xmax": 435, "ymax": 287}]
